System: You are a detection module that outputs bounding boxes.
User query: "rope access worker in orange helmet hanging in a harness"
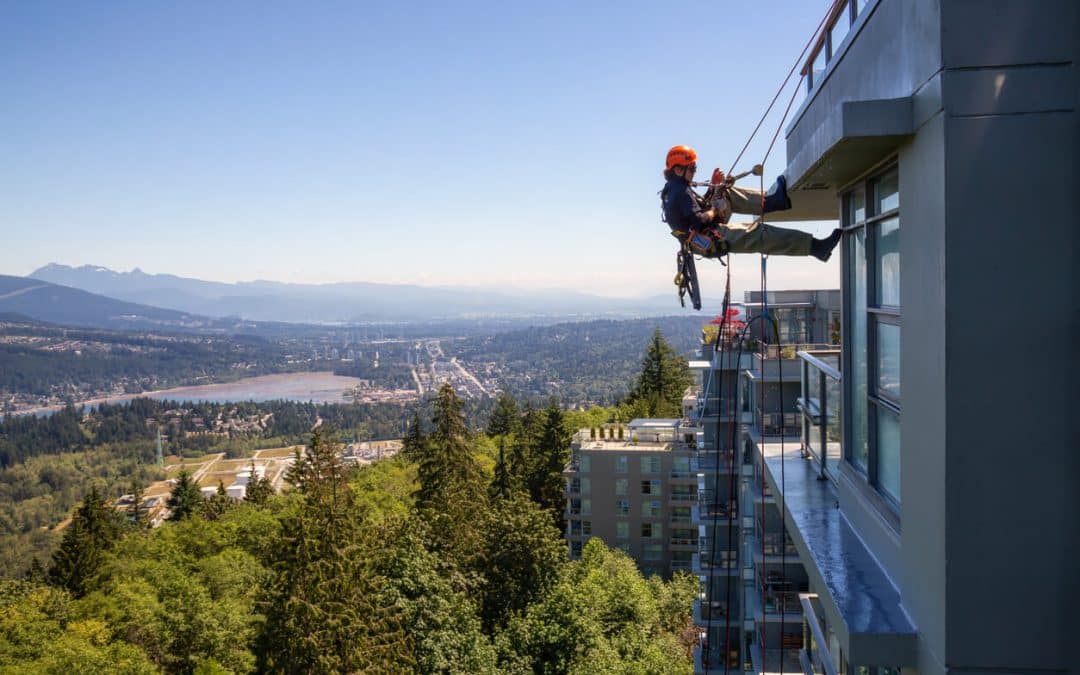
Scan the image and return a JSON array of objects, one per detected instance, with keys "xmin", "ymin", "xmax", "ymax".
[{"xmin": 660, "ymin": 146, "xmax": 841, "ymax": 262}]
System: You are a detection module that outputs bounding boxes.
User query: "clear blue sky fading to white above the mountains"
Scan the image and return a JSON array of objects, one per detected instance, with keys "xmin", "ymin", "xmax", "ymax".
[{"xmin": 0, "ymin": 0, "xmax": 838, "ymax": 295}]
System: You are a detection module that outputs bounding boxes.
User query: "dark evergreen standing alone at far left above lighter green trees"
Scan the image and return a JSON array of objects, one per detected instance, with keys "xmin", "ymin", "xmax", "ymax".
[{"xmin": 49, "ymin": 487, "xmax": 120, "ymax": 597}]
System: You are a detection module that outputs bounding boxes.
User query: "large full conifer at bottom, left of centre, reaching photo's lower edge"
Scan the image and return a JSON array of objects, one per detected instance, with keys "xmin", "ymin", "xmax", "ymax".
[{"xmin": 257, "ymin": 429, "xmax": 411, "ymax": 673}]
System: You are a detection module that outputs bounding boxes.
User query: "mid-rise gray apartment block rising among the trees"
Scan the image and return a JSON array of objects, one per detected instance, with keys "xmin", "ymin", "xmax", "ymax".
[{"xmin": 563, "ymin": 419, "xmax": 698, "ymax": 577}]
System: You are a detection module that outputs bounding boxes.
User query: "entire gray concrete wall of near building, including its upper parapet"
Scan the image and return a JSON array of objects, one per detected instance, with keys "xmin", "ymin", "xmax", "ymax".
[{"xmin": 787, "ymin": 0, "xmax": 1080, "ymax": 673}]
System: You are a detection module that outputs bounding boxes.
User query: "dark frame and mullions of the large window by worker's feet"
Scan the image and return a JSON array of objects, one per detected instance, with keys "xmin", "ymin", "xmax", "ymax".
[{"xmin": 840, "ymin": 162, "xmax": 904, "ymax": 509}]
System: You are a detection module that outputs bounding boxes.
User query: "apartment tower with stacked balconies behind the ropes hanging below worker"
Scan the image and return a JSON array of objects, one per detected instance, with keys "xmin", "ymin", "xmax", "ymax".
[{"xmin": 690, "ymin": 289, "xmax": 840, "ymax": 673}]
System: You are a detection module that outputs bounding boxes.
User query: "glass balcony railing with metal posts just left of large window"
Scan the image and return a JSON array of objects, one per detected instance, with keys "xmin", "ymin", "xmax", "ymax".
[{"xmin": 796, "ymin": 349, "xmax": 843, "ymax": 478}]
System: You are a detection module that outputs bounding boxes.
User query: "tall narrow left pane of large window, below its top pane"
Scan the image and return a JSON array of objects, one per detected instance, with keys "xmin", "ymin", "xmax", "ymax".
[{"xmin": 845, "ymin": 229, "xmax": 869, "ymax": 471}]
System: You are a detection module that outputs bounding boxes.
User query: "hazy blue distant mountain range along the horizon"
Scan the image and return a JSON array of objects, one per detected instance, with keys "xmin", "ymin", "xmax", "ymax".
[{"xmin": 29, "ymin": 264, "xmax": 678, "ymax": 323}]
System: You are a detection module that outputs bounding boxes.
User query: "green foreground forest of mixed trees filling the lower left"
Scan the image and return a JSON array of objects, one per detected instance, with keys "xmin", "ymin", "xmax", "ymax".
[{"xmin": 0, "ymin": 379, "xmax": 698, "ymax": 674}]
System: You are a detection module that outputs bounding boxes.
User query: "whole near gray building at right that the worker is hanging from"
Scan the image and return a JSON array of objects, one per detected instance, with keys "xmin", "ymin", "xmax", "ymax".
[{"xmin": 696, "ymin": 0, "xmax": 1080, "ymax": 675}]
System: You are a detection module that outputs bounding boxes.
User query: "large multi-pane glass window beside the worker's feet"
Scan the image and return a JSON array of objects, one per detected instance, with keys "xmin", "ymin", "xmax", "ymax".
[{"xmin": 843, "ymin": 166, "xmax": 902, "ymax": 504}]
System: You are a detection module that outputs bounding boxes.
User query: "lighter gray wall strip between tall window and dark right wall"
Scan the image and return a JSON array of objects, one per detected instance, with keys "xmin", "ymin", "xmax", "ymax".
[{"xmin": 894, "ymin": 112, "xmax": 946, "ymax": 673}]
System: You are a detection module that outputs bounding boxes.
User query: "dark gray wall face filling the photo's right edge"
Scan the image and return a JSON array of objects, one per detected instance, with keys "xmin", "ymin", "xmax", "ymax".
[{"xmin": 937, "ymin": 0, "xmax": 1080, "ymax": 672}]
